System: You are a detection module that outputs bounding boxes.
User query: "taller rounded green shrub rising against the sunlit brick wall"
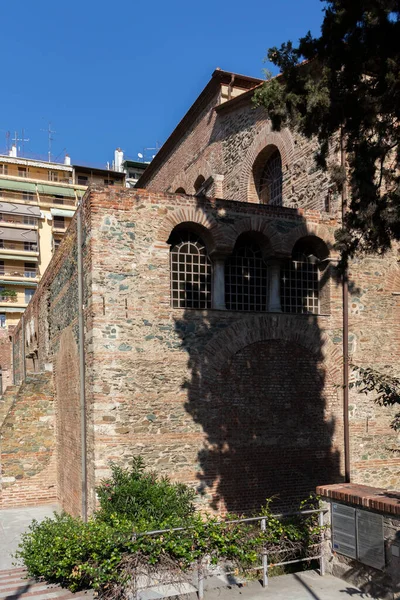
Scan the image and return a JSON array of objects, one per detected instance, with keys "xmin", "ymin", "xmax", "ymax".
[{"xmin": 96, "ymin": 456, "xmax": 195, "ymax": 531}]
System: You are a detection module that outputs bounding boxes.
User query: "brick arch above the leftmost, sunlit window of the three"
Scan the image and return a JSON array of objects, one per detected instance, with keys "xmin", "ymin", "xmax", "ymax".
[{"xmin": 157, "ymin": 207, "xmax": 231, "ymax": 254}]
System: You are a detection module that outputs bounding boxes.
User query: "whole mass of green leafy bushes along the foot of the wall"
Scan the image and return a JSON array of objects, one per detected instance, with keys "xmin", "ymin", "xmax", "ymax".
[{"xmin": 17, "ymin": 459, "xmax": 321, "ymax": 598}]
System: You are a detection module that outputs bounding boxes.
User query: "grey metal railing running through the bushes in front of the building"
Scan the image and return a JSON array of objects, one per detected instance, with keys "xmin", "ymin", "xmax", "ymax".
[{"xmin": 134, "ymin": 508, "xmax": 328, "ymax": 600}]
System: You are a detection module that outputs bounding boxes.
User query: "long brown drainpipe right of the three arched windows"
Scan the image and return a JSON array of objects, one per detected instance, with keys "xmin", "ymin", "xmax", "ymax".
[{"xmin": 340, "ymin": 129, "xmax": 351, "ymax": 483}]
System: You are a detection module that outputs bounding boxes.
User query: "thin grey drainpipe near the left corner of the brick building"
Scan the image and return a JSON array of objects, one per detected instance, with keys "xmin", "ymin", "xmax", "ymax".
[{"xmin": 76, "ymin": 202, "xmax": 88, "ymax": 523}]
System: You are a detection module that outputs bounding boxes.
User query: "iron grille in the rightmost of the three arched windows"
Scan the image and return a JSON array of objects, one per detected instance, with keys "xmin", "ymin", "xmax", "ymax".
[{"xmin": 281, "ymin": 254, "xmax": 319, "ymax": 315}]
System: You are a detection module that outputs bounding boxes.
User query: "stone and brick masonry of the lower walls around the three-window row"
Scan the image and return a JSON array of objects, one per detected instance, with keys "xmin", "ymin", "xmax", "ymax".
[{"xmin": 3, "ymin": 188, "xmax": 400, "ymax": 514}]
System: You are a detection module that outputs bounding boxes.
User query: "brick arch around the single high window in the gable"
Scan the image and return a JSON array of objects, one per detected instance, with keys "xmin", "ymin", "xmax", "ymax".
[{"xmin": 240, "ymin": 122, "xmax": 294, "ymax": 202}]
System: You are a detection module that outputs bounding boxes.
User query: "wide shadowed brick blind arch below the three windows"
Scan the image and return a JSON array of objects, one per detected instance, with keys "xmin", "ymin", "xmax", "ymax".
[{"xmin": 204, "ymin": 314, "xmax": 342, "ymax": 385}]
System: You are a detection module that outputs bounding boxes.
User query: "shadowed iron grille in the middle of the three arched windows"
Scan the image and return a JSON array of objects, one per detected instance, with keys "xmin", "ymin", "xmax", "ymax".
[{"xmin": 225, "ymin": 242, "xmax": 268, "ymax": 311}]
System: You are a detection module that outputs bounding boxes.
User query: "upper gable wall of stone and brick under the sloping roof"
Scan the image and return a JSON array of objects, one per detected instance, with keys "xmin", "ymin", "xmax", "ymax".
[{"xmin": 145, "ymin": 85, "xmax": 339, "ymax": 212}]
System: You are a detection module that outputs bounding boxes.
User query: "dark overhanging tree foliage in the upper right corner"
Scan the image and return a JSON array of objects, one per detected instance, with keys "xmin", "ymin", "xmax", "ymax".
[{"xmin": 255, "ymin": 0, "xmax": 400, "ymax": 256}]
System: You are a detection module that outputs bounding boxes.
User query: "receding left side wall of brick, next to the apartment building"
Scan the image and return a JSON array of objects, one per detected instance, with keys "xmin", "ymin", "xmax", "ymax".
[{"xmin": 10, "ymin": 195, "xmax": 92, "ymax": 514}]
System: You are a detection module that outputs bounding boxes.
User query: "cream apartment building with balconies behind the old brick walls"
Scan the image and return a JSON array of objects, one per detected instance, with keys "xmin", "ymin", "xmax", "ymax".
[{"xmin": 0, "ymin": 146, "xmax": 125, "ymax": 328}]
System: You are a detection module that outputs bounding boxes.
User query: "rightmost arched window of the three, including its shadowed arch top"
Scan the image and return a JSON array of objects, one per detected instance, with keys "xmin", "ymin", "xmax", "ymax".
[{"xmin": 281, "ymin": 238, "xmax": 329, "ymax": 314}]
